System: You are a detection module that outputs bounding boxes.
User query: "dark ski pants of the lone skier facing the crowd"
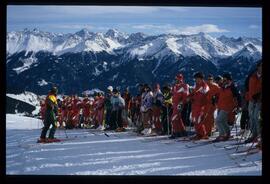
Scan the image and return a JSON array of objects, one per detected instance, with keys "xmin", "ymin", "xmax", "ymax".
[{"xmin": 40, "ymin": 111, "xmax": 56, "ymax": 139}]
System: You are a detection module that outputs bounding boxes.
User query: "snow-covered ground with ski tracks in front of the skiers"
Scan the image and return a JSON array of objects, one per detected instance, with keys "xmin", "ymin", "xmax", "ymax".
[{"xmin": 6, "ymin": 114, "xmax": 262, "ymax": 176}]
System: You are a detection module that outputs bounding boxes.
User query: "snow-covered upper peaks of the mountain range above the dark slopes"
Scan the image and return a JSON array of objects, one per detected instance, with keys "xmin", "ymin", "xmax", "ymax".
[{"xmin": 7, "ymin": 29, "xmax": 262, "ymax": 60}]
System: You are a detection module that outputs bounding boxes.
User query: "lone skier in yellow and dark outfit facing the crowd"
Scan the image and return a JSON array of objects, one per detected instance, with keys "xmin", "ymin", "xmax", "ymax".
[{"xmin": 38, "ymin": 87, "xmax": 60, "ymax": 143}]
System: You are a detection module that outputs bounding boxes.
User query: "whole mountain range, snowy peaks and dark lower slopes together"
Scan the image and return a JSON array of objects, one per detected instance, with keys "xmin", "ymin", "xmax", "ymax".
[{"xmin": 6, "ymin": 29, "xmax": 262, "ymax": 94}]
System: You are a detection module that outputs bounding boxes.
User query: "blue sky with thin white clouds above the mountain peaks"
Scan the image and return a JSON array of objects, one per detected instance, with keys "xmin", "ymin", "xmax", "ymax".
[{"xmin": 7, "ymin": 5, "xmax": 262, "ymax": 38}]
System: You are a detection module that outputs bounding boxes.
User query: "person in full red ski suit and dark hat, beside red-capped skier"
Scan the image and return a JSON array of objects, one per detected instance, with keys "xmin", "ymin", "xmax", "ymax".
[{"xmin": 189, "ymin": 72, "xmax": 209, "ymax": 140}]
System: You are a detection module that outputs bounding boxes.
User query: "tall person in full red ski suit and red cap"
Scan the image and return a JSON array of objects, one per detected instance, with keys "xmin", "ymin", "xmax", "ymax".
[{"xmin": 170, "ymin": 74, "xmax": 189, "ymax": 139}]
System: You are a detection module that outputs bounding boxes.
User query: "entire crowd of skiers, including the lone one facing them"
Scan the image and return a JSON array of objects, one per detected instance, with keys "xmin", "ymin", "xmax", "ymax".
[{"xmin": 38, "ymin": 62, "xmax": 262, "ymax": 147}]
